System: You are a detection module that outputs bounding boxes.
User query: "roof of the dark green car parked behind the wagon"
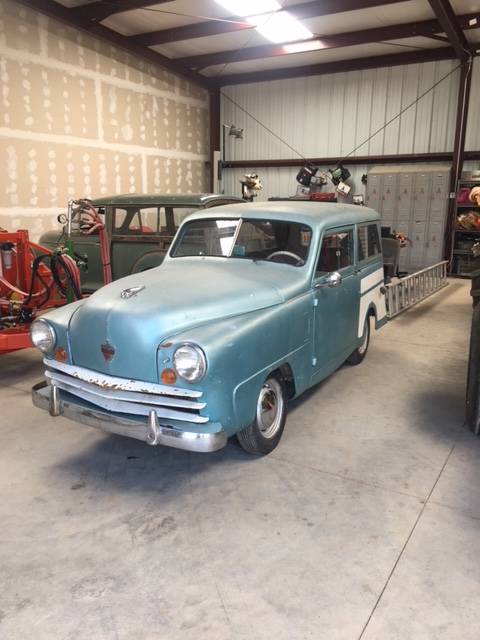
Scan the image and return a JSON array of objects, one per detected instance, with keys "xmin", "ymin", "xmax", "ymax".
[{"xmin": 92, "ymin": 193, "xmax": 244, "ymax": 207}]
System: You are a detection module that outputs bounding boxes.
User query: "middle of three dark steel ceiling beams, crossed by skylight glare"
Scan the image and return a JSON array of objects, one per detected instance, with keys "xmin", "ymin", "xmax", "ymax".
[{"xmin": 176, "ymin": 13, "xmax": 480, "ymax": 69}]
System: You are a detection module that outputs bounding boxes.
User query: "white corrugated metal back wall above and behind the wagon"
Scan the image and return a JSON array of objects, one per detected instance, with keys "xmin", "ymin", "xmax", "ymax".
[{"xmin": 221, "ymin": 60, "xmax": 480, "ymax": 200}]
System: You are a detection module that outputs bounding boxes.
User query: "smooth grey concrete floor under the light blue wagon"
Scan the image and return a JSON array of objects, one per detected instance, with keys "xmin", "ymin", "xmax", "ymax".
[{"xmin": 0, "ymin": 281, "xmax": 480, "ymax": 640}]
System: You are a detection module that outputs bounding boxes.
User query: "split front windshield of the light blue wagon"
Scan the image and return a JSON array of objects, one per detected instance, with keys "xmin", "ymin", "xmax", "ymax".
[{"xmin": 170, "ymin": 218, "xmax": 312, "ymax": 267}]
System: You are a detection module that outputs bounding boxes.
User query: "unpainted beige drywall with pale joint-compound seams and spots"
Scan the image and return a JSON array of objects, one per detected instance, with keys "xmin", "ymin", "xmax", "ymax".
[{"xmin": 0, "ymin": 0, "xmax": 209, "ymax": 239}]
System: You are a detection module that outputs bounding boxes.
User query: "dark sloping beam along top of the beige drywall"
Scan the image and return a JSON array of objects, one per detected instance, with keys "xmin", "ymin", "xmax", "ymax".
[{"xmin": 16, "ymin": 0, "xmax": 210, "ymax": 88}]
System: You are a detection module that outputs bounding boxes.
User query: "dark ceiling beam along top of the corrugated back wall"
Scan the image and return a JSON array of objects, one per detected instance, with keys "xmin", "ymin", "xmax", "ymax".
[{"xmin": 210, "ymin": 47, "xmax": 456, "ymax": 87}]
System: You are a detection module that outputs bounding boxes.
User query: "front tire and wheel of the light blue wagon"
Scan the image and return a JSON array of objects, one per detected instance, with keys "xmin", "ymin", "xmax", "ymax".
[{"xmin": 237, "ymin": 376, "xmax": 287, "ymax": 455}]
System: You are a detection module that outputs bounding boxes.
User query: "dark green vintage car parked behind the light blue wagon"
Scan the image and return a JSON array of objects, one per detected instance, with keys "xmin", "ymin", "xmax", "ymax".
[{"xmin": 39, "ymin": 193, "xmax": 244, "ymax": 293}]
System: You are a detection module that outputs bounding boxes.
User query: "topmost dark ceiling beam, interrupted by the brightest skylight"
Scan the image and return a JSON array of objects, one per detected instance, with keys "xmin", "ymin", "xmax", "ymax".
[{"xmin": 131, "ymin": 0, "xmax": 405, "ymax": 47}]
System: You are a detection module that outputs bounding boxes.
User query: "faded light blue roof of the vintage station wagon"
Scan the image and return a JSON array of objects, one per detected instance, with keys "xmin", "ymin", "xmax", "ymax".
[{"xmin": 188, "ymin": 201, "xmax": 380, "ymax": 228}]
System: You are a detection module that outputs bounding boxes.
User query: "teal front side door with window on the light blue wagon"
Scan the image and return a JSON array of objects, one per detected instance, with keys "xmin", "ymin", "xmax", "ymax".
[{"xmin": 312, "ymin": 225, "xmax": 359, "ymax": 380}]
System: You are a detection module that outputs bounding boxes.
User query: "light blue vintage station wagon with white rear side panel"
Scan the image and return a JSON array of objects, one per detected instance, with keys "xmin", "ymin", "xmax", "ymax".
[{"xmin": 32, "ymin": 202, "xmax": 386, "ymax": 454}]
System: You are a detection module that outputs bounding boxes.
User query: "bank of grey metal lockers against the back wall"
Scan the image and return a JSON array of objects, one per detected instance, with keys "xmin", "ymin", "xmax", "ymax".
[{"xmin": 366, "ymin": 164, "xmax": 450, "ymax": 273}]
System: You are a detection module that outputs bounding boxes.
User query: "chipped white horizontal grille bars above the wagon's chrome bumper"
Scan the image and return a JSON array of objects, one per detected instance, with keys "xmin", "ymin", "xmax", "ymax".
[{"xmin": 44, "ymin": 359, "xmax": 208, "ymax": 424}]
